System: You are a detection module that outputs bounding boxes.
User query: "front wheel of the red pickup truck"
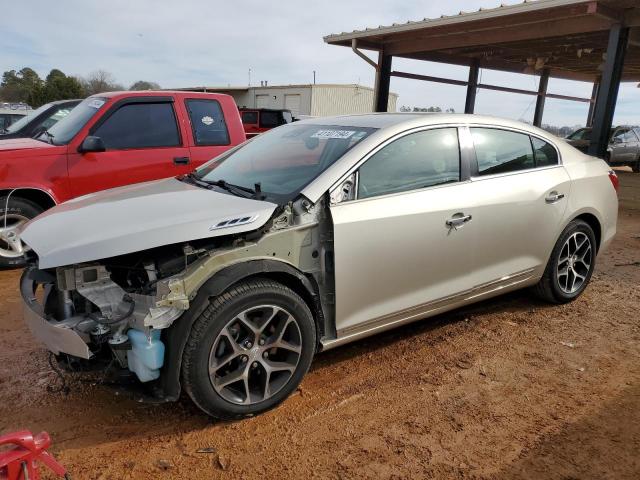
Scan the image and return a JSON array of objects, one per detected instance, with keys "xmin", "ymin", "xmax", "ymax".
[{"xmin": 0, "ymin": 196, "xmax": 43, "ymax": 269}]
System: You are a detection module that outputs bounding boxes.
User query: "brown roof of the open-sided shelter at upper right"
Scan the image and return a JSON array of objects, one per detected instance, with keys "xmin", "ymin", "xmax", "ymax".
[{"xmin": 324, "ymin": 0, "xmax": 640, "ymax": 81}]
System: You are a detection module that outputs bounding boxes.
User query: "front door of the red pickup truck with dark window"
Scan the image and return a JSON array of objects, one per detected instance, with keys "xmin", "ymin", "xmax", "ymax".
[{"xmin": 68, "ymin": 97, "xmax": 189, "ymax": 196}]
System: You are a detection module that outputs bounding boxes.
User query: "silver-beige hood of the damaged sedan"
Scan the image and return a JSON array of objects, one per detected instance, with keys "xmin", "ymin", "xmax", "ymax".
[{"xmin": 20, "ymin": 178, "xmax": 277, "ymax": 268}]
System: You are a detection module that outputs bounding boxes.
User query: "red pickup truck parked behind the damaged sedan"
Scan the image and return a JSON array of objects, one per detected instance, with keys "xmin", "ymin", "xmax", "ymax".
[{"xmin": 0, "ymin": 91, "xmax": 246, "ymax": 267}]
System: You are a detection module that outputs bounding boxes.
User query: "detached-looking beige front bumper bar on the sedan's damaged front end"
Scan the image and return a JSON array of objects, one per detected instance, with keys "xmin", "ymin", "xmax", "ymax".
[{"xmin": 20, "ymin": 269, "xmax": 92, "ymax": 359}]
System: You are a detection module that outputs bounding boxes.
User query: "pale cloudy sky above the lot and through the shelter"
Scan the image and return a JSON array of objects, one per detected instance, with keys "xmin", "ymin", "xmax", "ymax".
[{"xmin": 5, "ymin": 0, "xmax": 640, "ymax": 125}]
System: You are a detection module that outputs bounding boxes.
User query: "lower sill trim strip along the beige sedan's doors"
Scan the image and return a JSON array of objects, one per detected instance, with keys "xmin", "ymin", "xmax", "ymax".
[{"xmin": 320, "ymin": 268, "xmax": 536, "ymax": 350}]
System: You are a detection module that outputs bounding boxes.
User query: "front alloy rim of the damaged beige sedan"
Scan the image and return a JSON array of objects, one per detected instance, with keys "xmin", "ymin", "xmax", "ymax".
[{"xmin": 209, "ymin": 305, "xmax": 302, "ymax": 405}]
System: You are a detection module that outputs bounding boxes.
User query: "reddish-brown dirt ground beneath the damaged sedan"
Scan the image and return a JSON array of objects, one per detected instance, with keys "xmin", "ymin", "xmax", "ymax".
[{"xmin": 0, "ymin": 173, "xmax": 640, "ymax": 480}]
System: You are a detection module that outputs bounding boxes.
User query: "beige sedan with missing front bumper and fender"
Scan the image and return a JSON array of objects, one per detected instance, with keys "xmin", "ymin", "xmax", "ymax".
[{"xmin": 21, "ymin": 114, "xmax": 617, "ymax": 419}]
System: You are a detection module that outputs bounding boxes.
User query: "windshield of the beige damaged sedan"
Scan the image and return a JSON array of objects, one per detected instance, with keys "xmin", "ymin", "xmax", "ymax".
[{"xmin": 196, "ymin": 122, "xmax": 376, "ymax": 203}]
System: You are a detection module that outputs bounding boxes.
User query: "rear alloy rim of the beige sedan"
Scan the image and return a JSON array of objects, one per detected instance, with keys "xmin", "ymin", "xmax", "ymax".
[{"xmin": 556, "ymin": 232, "xmax": 593, "ymax": 294}]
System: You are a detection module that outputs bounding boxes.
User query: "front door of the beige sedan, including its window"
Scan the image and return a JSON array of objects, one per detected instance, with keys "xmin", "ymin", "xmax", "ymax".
[{"xmin": 331, "ymin": 127, "xmax": 475, "ymax": 336}]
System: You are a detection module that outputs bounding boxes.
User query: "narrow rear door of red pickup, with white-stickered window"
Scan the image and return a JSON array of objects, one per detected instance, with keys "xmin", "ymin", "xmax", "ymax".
[{"xmin": 184, "ymin": 98, "xmax": 235, "ymax": 166}]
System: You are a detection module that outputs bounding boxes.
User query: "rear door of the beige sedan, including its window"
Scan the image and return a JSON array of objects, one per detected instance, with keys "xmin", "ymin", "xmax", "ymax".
[{"xmin": 460, "ymin": 126, "xmax": 571, "ymax": 285}]
